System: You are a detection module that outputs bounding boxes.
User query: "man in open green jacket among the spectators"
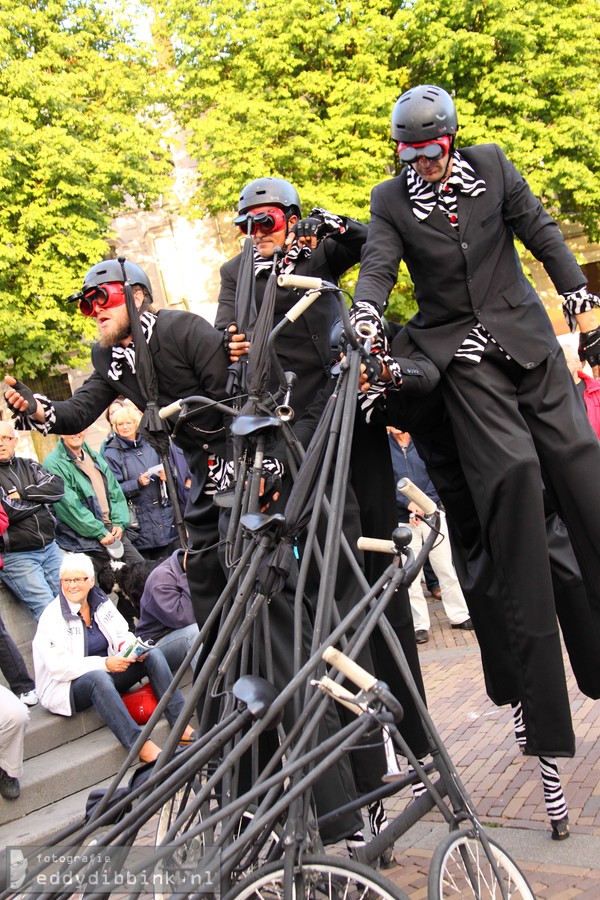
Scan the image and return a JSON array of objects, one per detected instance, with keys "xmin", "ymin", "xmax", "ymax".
[{"xmin": 44, "ymin": 431, "xmax": 142, "ymax": 571}]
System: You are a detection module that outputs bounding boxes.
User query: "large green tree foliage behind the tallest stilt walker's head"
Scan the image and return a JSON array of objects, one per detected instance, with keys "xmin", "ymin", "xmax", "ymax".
[{"xmin": 152, "ymin": 0, "xmax": 600, "ymax": 319}]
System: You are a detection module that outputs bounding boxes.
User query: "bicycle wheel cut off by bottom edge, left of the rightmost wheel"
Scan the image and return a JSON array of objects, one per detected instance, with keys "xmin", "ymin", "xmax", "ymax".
[{"xmin": 226, "ymin": 856, "xmax": 407, "ymax": 900}]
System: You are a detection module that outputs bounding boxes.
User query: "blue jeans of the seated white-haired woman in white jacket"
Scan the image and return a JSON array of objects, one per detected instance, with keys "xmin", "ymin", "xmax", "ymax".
[{"xmin": 71, "ymin": 648, "xmax": 184, "ymax": 750}]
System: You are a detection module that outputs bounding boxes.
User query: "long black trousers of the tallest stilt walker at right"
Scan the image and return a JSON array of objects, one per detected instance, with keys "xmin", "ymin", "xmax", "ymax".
[{"xmin": 442, "ymin": 342, "xmax": 600, "ymax": 756}]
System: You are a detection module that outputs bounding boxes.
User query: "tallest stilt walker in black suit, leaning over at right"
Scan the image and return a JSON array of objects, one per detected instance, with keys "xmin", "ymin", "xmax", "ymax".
[{"xmin": 352, "ymin": 85, "xmax": 600, "ymax": 756}]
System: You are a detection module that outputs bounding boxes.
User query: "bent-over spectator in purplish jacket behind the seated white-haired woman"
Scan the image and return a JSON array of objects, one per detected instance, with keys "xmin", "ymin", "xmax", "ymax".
[{"xmin": 119, "ymin": 550, "xmax": 200, "ymax": 672}]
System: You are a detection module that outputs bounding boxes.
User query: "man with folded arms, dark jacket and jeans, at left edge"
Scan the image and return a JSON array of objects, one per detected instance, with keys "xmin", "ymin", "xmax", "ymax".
[{"xmin": 0, "ymin": 422, "xmax": 64, "ymax": 619}]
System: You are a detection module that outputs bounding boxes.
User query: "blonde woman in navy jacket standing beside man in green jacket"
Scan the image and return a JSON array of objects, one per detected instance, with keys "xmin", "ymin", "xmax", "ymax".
[{"xmin": 103, "ymin": 406, "xmax": 177, "ymax": 559}]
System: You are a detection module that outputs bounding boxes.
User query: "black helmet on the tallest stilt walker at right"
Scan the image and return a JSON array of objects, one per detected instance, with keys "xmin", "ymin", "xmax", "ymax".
[{"xmin": 391, "ymin": 84, "xmax": 458, "ymax": 144}]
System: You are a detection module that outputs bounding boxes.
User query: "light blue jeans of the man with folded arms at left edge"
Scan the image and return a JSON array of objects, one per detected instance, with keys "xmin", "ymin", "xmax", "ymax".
[{"xmin": 0, "ymin": 541, "xmax": 63, "ymax": 619}]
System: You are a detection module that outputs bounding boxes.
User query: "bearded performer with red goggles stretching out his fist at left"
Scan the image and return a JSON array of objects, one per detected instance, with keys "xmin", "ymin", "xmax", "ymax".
[{"xmin": 5, "ymin": 259, "xmax": 227, "ymax": 622}]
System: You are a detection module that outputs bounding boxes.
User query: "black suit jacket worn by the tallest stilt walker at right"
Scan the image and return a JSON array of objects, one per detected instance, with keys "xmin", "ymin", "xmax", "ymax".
[{"xmin": 355, "ymin": 144, "xmax": 586, "ymax": 370}]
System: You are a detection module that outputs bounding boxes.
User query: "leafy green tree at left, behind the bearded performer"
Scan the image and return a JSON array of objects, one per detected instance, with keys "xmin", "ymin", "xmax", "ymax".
[{"xmin": 0, "ymin": 0, "xmax": 170, "ymax": 378}]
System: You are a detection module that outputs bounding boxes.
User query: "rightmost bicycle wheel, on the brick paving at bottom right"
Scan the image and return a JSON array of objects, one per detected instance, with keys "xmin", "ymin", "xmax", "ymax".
[{"xmin": 428, "ymin": 831, "xmax": 535, "ymax": 900}]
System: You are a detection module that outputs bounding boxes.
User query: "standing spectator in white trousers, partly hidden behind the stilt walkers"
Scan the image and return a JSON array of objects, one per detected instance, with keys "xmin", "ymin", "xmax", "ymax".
[{"xmin": 388, "ymin": 427, "xmax": 473, "ymax": 644}]
